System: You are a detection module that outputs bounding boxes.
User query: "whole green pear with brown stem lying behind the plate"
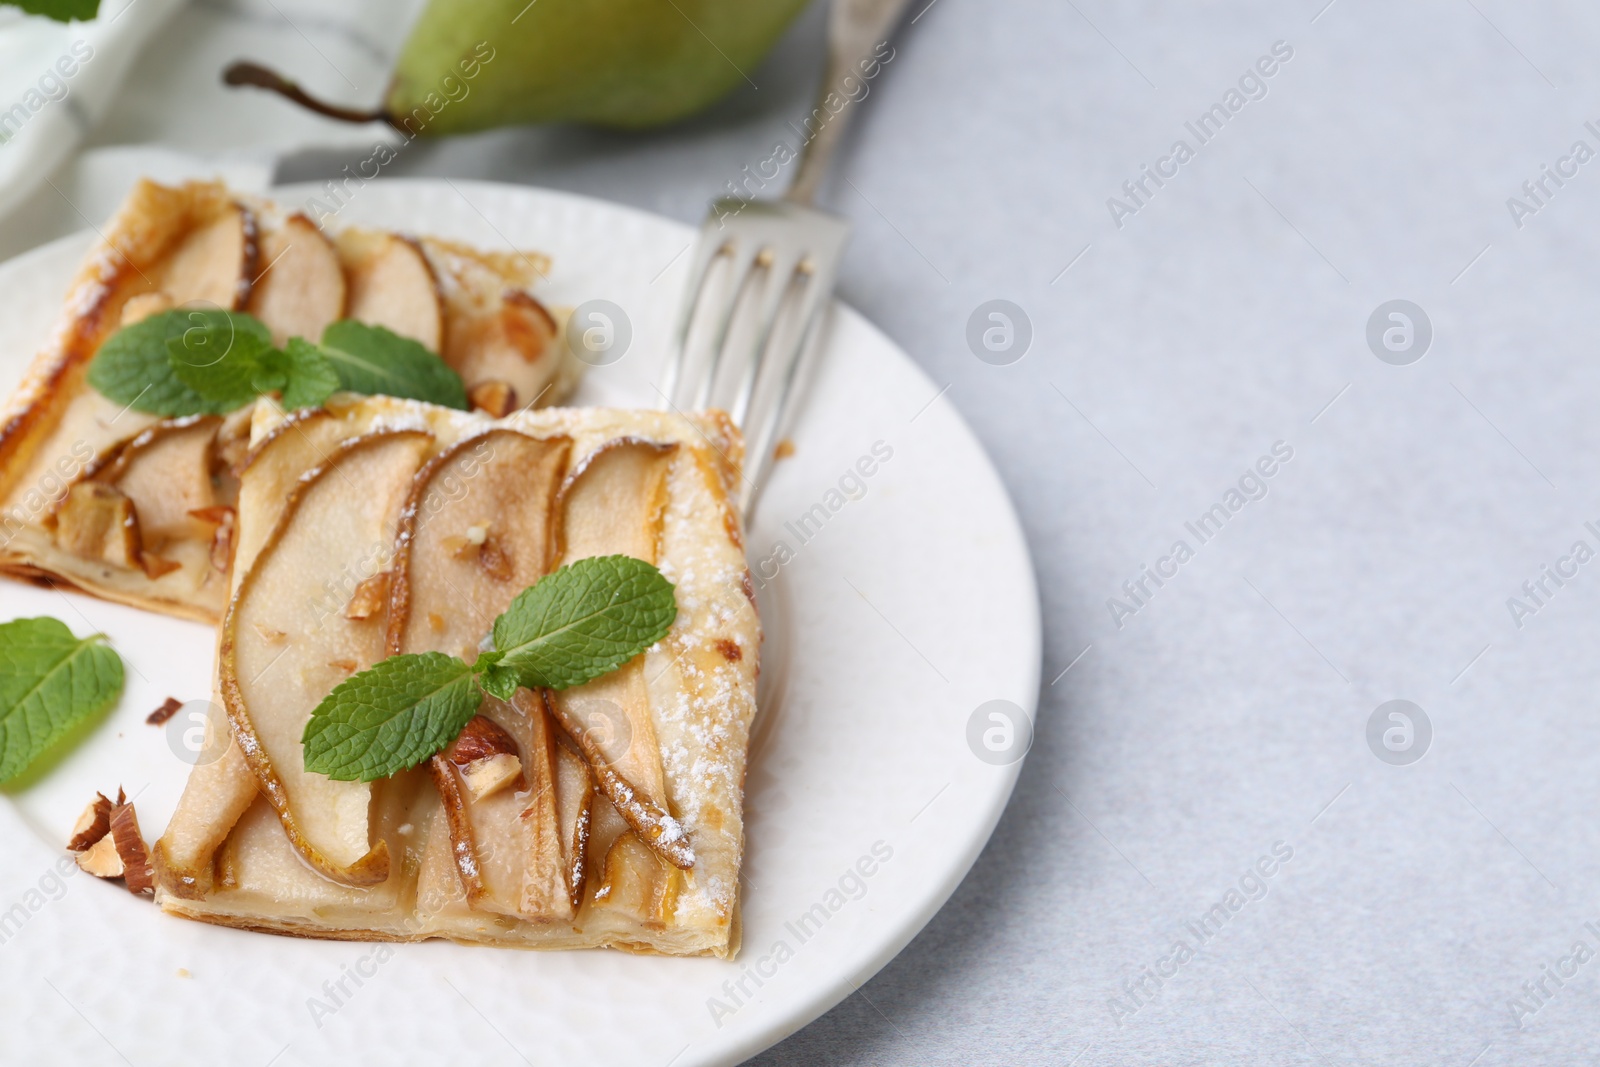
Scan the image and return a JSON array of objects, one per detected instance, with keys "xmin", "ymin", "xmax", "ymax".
[{"xmin": 224, "ymin": 0, "xmax": 806, "ymax": 134}]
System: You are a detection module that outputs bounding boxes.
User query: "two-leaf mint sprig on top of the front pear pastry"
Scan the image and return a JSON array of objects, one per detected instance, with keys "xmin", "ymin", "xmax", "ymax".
[{"xmin": 301, "ymin": 555, "xmax": 678, "ymax": 782}]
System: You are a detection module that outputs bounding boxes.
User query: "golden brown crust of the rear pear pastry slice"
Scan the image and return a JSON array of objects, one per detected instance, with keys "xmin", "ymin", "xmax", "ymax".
[{"xmin": 0, "ymin": 181, "xmax": 581, "ymax": 622}]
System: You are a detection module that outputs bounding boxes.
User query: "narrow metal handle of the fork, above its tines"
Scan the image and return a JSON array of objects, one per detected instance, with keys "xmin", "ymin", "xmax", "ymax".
[{"xmin": 784, "ymin": 0, "xmax": 910, "ymax": 205}]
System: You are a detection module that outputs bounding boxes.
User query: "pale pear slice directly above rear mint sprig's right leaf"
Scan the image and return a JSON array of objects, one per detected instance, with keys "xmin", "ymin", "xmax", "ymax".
[{"xmin": 342, "ymin": 230, "xmax": 445, "ymax": 352}]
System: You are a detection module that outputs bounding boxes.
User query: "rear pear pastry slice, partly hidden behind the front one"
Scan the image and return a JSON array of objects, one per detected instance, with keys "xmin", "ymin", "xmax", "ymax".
[{"xmin": 0, "ymin": 181, "xmax": 581, "ymax": 622}]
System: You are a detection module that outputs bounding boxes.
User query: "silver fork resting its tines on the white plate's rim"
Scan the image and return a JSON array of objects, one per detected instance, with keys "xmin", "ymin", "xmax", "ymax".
[{"xmin": 661, "ymin": 0, "xmax": 909, "ymax": 515}]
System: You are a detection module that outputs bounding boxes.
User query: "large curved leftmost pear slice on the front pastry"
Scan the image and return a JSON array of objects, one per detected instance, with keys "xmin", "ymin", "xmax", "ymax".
[{"xmin": 219, "ymin": 430, "xmax": 434, "ymax": 886}]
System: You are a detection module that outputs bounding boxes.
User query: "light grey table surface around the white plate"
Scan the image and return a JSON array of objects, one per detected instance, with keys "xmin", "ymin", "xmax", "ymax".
[{"xmin": 18, "ymin": 0, "xmax": 1600, "ymax": 1067}]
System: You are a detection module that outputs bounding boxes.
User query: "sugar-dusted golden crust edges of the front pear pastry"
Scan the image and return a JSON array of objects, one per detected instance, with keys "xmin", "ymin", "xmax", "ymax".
[{"xmin": 155, "ymin": 398, "xmax": 760, "ymax": 958}]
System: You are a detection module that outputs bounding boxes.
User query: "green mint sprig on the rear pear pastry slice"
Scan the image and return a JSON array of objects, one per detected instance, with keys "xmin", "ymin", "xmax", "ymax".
[{"xmin": 88, "ymin": 309, "xmax": 467, "ymax": 416}]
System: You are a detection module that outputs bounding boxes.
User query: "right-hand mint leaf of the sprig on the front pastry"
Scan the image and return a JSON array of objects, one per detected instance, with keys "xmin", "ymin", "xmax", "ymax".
[{"xmin": 494, "ymin": 555, "xmax": 678, "ymax": 689}]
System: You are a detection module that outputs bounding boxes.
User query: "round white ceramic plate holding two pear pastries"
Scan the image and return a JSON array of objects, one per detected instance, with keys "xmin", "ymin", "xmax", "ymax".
[{"xmin": 0, "ymin": 182, "xmax": 1040, "ymax": 1067}]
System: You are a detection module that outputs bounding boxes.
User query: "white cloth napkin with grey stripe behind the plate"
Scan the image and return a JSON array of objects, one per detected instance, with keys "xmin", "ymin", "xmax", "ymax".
[{"xmin": 0, "ymin": 0, "xmax": 424, "ymax": 259}]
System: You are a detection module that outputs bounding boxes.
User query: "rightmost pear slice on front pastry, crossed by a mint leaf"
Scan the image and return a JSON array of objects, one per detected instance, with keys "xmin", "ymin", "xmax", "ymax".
[{"xmin": 550, "ymin": 438, "xmax": 694, "ymax": 869}]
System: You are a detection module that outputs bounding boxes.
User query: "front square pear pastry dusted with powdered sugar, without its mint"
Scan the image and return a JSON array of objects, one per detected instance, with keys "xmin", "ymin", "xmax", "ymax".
[{"xmin": 154, "ymin": 397, "xmax": 760, "ymax": 958}]
